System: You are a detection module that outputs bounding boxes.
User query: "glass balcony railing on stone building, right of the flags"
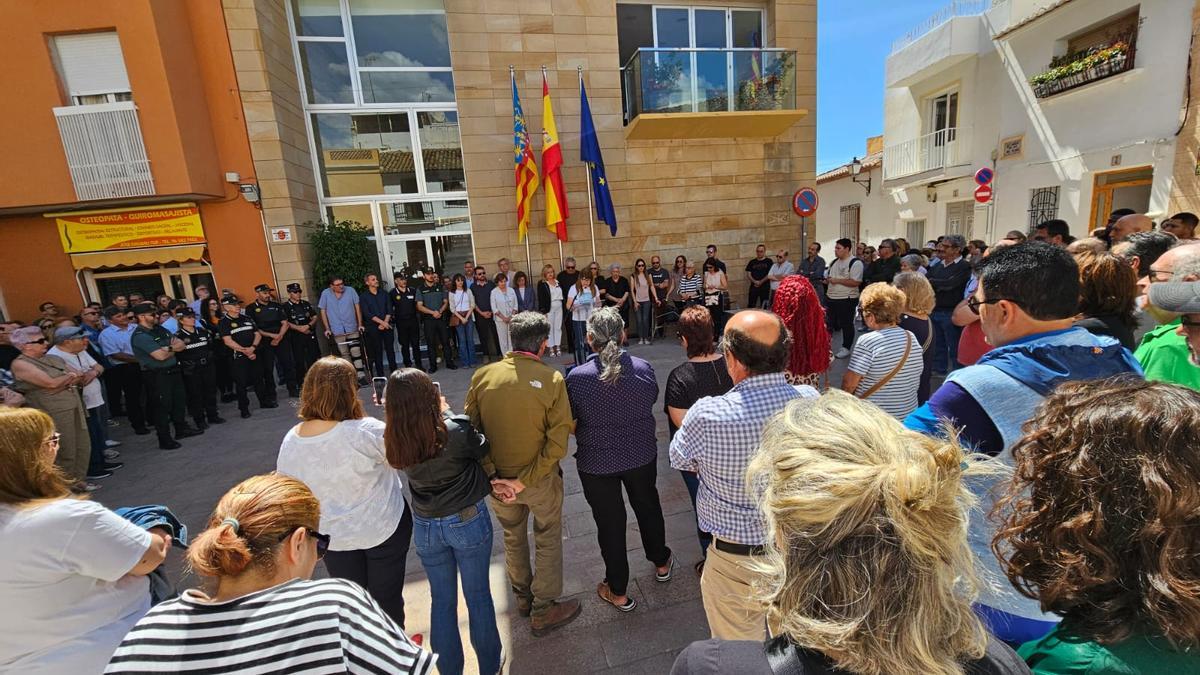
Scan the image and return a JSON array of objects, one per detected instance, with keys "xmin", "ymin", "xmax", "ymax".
[{"xmin": 623, "ymin": 48, "xmax": 796, "ymax": 121}]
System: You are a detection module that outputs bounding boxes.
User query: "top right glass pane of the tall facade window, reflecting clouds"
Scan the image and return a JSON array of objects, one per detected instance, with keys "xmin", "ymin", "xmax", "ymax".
[{"xmin": 350, "ymin": 0, "xmax": 450, "ymax": 67}]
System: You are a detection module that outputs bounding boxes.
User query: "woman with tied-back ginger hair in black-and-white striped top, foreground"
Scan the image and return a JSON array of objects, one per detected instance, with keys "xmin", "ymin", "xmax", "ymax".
[{"xmin": 106, "ymin": 474, "xmax": 437, "ymax": 675}]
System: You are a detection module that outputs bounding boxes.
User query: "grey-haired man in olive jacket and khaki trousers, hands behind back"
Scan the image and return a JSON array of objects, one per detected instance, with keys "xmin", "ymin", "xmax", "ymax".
[{"xmin": 463, "ymin": 311, "xmax": 581, "ymax": 637}]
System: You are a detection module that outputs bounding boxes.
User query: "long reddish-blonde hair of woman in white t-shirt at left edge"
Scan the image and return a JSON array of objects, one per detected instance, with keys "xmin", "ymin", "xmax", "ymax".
[{"xmin": 0, "ymin": 408, "xmax": 71, "ymax": 507}]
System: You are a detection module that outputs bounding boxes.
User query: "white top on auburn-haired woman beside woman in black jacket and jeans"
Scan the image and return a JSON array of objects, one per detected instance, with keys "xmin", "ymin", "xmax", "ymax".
[{"xmin": 275, "ymin": 417, "xmax": 404, "ymax": 551}]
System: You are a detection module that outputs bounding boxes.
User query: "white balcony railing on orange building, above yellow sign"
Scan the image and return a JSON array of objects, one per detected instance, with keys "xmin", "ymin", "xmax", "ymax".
[{"xmin": 54, "ymin": 101, "xmax": 154, "ymax": 201}]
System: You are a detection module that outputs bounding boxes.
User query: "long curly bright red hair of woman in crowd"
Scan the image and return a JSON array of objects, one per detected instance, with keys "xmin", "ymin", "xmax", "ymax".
[{"xmin": 770, "ymin": 274, "xmax": 833, "ymax": 388}]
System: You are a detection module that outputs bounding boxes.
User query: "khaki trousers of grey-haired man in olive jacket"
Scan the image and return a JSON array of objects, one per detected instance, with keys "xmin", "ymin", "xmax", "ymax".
[{"xmin": 490, "ymin": 470, "xmax": 563, "ymax": 616}]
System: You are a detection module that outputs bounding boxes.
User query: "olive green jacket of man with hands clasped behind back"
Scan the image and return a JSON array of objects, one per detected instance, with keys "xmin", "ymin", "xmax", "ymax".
[{"xmin": 463, "ymin": 352, "xmax": 572, "ymax": 486}]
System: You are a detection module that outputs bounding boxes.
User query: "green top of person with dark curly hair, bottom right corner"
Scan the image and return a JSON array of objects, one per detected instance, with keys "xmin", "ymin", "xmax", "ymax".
[{"xmin": 1018, "ymin": 625, "xmax": 1200, "ymax": 675}]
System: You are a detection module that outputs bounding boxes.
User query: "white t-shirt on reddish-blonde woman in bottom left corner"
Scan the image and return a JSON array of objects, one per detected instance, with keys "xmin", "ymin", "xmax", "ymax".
[{"xmin": 0, "ymin": 498, "xmax": 154, "ymax": 675}]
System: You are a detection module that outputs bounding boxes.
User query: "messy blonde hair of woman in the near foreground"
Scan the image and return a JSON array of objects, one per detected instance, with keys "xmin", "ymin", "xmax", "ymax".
[{"xmin": 746, "ymin": 390, "xmax": 996, "ymax": 675}]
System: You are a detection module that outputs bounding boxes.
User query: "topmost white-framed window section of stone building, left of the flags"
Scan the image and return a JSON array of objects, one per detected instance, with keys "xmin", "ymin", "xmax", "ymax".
[{"xmin": 290, "ymin": 0, "xmax": 455, "ymax": 106}]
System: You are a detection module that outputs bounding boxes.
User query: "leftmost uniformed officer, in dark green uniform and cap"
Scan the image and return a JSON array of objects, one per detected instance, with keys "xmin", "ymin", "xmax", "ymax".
[{"xmin": 130, "ymin": 303, "xmax": 203, "ymax": 450}]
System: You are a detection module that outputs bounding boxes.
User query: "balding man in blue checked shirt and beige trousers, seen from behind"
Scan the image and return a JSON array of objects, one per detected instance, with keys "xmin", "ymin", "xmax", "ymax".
[{"xmin": 671, "ymin": 310, "xmax": 818, "ymax": 643}]
